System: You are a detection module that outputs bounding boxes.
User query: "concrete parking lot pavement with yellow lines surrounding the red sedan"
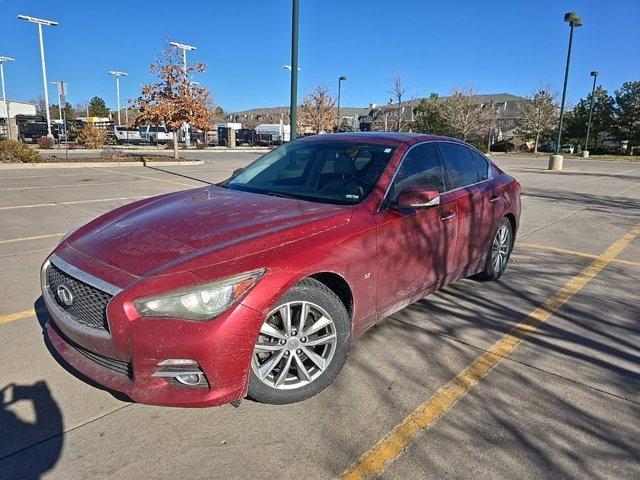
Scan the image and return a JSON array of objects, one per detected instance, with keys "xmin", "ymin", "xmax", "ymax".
[{"xmin": 0, "ymin": 153, "xmax": 640, "ymax": 480}]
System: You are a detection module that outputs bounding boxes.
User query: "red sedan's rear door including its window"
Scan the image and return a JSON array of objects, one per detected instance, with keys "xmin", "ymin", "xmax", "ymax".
[{"xmin": 438, "ymin": 141, "xmax": 486, "ymax": 275}]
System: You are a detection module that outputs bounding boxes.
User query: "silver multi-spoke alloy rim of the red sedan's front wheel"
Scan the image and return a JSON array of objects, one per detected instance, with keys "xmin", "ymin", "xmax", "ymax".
[{"xmin": 251, "ymin": 301, "xmax": 337, "ymax": 390}]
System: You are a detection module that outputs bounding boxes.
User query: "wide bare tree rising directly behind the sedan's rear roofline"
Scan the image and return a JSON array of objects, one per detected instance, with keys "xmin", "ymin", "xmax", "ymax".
[{"xmin": 439, "ymin": 86, "xmax": 497, "ymax": 141}]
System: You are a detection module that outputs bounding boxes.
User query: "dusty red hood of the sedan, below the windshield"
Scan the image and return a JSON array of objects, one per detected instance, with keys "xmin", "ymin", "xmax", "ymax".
[{"xmin": 67, "ymin": 186, "xmax": 353, "ymax": 277}]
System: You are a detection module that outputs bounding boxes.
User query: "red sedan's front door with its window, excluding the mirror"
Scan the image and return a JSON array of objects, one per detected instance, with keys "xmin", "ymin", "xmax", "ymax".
[{"xmin": 374, "ymin": 142, "xmax": 457, "ymax": 315}]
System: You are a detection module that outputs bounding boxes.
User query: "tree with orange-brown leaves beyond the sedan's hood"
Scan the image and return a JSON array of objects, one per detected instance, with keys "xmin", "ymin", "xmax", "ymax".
[{"xmin": 132, "ymin": 48, "xmax": 213, "ymax": 158}]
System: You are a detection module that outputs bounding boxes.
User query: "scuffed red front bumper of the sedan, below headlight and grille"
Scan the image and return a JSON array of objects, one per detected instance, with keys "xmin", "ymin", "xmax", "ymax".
[{"xmin": 42, "ymin": 253, "xmax": 263, "ymax": 407}]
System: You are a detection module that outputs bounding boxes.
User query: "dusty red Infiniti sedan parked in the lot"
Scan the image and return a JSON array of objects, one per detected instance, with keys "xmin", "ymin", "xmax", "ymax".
[{"xmin": 41, "ymin": 133, "xmax": 520, "ymax": 407}]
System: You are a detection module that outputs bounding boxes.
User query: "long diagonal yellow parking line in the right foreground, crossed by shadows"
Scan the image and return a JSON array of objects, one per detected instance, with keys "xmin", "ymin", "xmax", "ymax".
[{"xmin": 341, "ymin": 224, "xmax": 640, "ymax": 480}]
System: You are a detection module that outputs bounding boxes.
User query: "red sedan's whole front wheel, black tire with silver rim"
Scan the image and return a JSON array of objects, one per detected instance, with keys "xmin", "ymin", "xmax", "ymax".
[{"xmin": 248, "ymin": 278, "xmax": 351, "ymax": 404}]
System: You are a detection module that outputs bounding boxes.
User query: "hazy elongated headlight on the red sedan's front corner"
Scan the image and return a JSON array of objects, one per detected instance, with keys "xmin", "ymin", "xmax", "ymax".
[{"xmin": 134, "ymin": 270, "xmax": 265, "ymax": 320}]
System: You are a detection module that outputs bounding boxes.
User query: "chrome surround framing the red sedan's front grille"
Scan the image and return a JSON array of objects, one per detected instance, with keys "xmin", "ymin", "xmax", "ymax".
[{"xmin": 40, "ymin": 254, "xmax": 122, "ymax": 339}]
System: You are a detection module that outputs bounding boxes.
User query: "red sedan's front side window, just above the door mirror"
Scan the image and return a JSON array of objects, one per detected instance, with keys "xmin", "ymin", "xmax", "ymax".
[{"xmin": 390, "ymin": 143, "xmax": 444, "ymax": 200}]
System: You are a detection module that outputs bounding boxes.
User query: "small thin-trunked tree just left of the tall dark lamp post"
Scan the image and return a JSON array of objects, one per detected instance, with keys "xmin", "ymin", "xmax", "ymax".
[{"xmin": 518, "ymin": 84, "xmax": 558, "ymax": 153}]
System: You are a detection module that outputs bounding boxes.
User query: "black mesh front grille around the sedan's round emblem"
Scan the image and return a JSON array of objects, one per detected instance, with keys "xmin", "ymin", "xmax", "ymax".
[{"xmin": 47, "ymin": 264, "xmax": 112, "ymax": 331}]
